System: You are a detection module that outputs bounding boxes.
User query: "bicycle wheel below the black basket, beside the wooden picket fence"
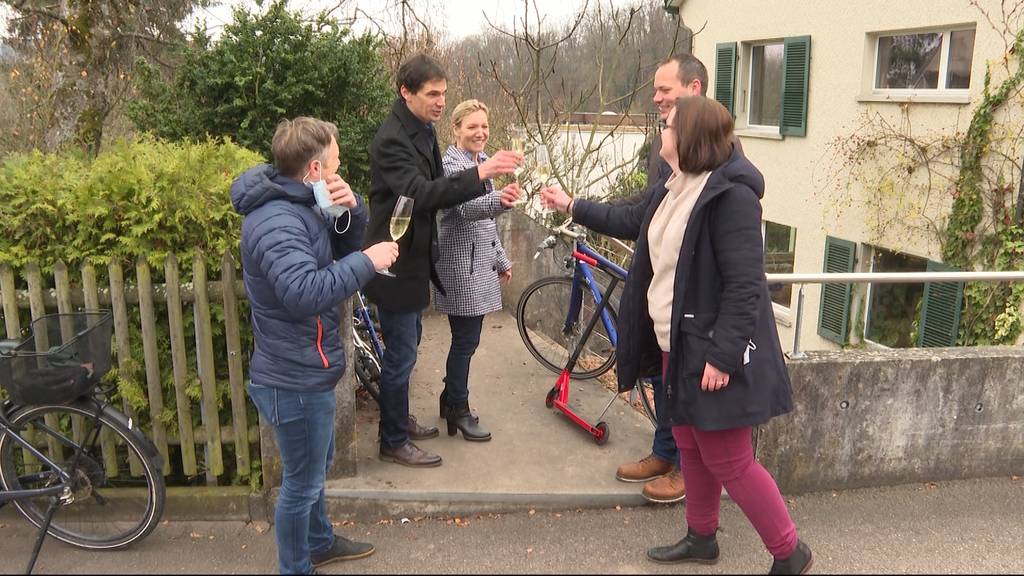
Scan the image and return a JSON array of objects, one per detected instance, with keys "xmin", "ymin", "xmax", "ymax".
[{"xmin": 0, "ymin": 403, "xmax": 166, "ymax": 549}]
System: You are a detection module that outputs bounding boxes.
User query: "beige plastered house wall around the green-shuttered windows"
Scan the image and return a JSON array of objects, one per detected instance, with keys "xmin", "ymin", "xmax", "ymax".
[{"xmin": 680, "ymin": 0, "xmax": 1006, "ymax": 349}]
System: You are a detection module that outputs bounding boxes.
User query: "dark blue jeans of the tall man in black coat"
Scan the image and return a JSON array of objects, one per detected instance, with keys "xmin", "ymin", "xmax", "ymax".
[{"xmin": 377, "ymin": 307, "xmax": 423, "ymax": 448}]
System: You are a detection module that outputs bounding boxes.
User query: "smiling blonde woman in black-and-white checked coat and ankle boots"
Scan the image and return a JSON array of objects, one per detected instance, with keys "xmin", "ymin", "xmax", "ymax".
[{"xmin": 432, "ymin": 99, "xmax": 519, "ymax": 442}]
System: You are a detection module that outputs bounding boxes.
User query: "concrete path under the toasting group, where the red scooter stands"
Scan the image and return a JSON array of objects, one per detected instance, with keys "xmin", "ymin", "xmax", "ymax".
[{"xmin": 328, "ymin": 313, "xmax": 653, "ymax": 515}]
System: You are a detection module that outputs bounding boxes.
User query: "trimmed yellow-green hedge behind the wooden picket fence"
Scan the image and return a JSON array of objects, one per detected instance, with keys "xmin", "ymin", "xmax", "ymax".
[{"xmin": 0, "ymin": 137, "xmax": 263, "ymax": 484}]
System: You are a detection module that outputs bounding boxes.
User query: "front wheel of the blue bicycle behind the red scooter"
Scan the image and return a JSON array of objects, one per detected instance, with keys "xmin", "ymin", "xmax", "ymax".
[{"xmin": 516, "ymin": 277, "xmax": 616, "ymax": 379}]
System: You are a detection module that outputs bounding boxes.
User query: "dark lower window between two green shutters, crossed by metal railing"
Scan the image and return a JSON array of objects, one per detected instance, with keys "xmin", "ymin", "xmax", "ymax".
[{"xmin": 867, "ymin": 248, "xmax": 928, "ymax": 348}]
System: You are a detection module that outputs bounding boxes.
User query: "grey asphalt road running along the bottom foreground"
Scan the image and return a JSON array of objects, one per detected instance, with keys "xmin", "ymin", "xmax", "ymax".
[{"xmin": 0, "ymin": 479, "xmax": 1024, "ymax": 574}]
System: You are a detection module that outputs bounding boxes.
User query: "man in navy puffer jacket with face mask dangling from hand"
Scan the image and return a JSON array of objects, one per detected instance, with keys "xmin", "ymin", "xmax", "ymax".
[{"xmin": 231, "ymin": 118, "xmax": 398, "ymax": 574}]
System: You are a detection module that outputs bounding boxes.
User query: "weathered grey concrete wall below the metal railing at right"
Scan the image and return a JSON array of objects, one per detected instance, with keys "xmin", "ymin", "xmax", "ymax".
[{"xmin": 757, "ymin": 346, "xmax": 1024, "ymax": 493}]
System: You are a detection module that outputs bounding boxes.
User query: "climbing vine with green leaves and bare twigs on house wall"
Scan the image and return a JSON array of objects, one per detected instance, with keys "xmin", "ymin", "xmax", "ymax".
[{"xmin": 823, "ymin": 14, "xmax": 1024, "ymax": 345}]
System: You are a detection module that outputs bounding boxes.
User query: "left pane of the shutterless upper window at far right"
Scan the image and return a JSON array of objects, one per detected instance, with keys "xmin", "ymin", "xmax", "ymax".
[{"xmin": 874, "ymin": 33, "xmax": 942, "ymax": 89}]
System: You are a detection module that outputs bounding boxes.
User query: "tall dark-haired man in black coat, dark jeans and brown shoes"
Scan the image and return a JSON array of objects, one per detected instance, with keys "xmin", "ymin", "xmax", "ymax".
[{"xmin": 366, "ymin": 54, "xmax": 522, "ymax": 467}]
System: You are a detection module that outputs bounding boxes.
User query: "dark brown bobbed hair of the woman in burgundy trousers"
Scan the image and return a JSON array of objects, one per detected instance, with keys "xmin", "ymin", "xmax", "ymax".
[{"xmin": 672, "ymin": 96, "xmax": 733, "ymax": 174}]
